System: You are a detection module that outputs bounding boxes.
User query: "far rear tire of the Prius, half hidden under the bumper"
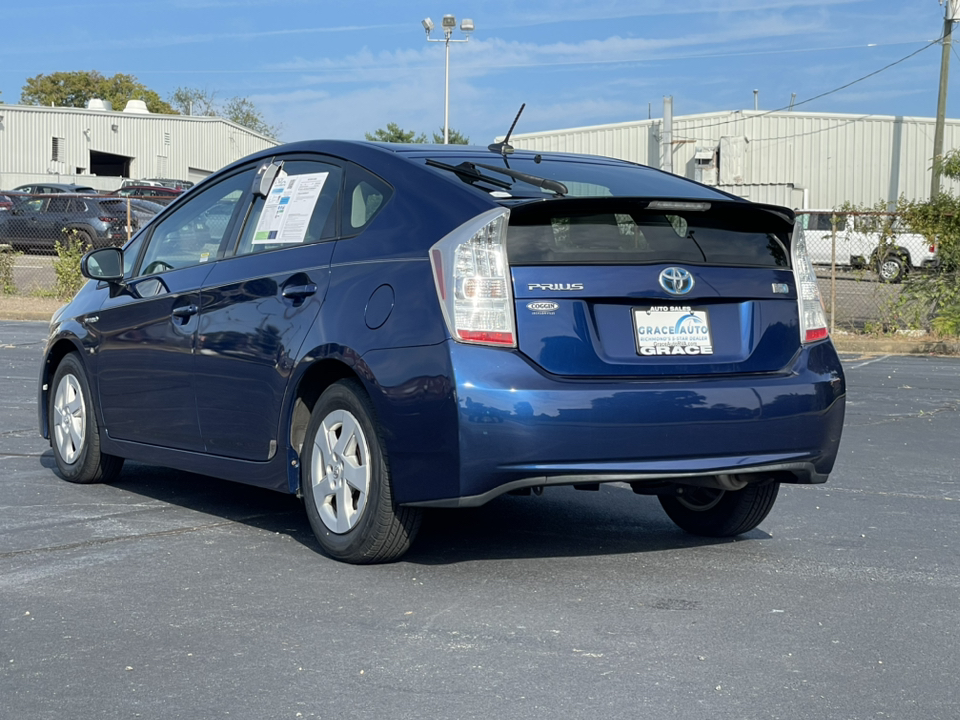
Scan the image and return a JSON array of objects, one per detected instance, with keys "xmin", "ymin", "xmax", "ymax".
[{"xmin": 659, "ymin": 482, "xmax": 780, "ymax": 537}]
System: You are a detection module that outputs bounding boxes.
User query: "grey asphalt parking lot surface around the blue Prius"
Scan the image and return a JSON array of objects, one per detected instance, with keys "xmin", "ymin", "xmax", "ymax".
[{"xmin": 0, "ymin": 322, "xmax": 960, "ymax": 720}]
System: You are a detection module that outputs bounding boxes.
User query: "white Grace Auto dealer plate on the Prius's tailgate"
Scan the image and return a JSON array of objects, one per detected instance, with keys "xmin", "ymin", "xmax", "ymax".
[{"xmin": 633, "ymin": 306, "xmax": 713, "ymax": 355}]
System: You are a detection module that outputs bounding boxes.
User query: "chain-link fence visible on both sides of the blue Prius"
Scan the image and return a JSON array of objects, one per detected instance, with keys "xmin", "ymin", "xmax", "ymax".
[{"xmin": 0, "ymin": 200, "xmax": 936, "ymax": 333}]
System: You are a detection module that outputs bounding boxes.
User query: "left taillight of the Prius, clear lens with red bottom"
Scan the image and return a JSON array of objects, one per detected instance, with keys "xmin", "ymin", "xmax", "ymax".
[{"xmin": 430, "ymin": 209, "xmax": 517, "ymax": 347}]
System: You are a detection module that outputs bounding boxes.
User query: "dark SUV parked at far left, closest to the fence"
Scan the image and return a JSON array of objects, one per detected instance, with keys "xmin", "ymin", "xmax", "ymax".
[{"xmin": 0, "ymin": 194, "xmax": 140, "ymax": 252}]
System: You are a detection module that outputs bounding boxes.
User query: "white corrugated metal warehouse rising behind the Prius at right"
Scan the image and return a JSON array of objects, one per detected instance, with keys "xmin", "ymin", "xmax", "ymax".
[{"xmin": 510, "ymin": 107, "xmax": 960, "ymax": 209}]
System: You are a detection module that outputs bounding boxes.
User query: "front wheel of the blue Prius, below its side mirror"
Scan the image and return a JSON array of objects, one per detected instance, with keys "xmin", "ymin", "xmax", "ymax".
[{"xmin": 47, "ymin": 353, "xmax": 123, "ymax": 483}]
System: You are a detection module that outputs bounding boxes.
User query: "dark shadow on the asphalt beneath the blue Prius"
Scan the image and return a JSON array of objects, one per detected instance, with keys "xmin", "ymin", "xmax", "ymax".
[{"xmin": 71, "ymin": 453, "xmax": 770, "ymax": 565}]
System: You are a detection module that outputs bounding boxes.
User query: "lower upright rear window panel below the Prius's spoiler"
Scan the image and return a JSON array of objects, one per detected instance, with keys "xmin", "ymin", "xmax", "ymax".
[{"xmin": 507, "ymin": 208, "xmax": 789, "ymax": 267}]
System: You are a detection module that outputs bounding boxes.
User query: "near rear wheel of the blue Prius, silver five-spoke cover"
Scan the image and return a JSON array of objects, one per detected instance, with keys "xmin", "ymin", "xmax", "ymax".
[{"xmin": 300, "ymin": 380, "xmax": 422, "ymax": 565}]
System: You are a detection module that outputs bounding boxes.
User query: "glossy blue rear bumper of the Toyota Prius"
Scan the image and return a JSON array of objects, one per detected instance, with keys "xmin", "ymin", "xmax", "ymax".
[{"xmin": 407, "ymin": 342, "xmax": 846, "ymax": 507}]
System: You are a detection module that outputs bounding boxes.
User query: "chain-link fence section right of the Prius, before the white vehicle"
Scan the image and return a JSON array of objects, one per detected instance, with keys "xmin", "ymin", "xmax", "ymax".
[{"xmin": 798, "ymin": 210, "xmax": 937, "ymax": 332}]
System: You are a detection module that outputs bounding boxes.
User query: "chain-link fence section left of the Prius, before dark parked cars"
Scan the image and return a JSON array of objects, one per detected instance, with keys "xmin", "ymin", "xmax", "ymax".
[{"xmin": 0, "ymin": 192, "xmax": 169, "ymax": 297}]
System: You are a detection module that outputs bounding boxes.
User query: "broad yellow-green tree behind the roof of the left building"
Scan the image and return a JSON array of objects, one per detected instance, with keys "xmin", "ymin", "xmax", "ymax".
[{"xmin": 20, "ymin": 70, "xmax": 176, "ymax": 115}]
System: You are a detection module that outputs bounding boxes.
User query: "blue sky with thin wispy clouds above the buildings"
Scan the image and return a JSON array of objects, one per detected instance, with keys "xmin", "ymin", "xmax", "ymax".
[{"xmin": 0, "ymin": 0, "xmax": 960, "ymax": 143}]
